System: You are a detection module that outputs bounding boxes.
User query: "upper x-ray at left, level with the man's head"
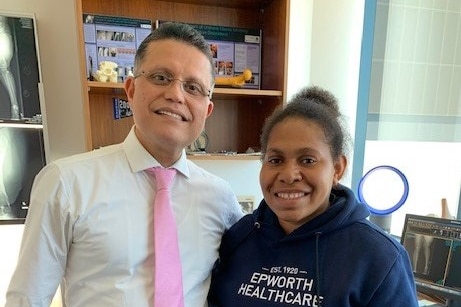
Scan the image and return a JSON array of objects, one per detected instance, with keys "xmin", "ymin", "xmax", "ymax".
[{"xmin": 0, "ymin": 14, "xmax": 40, "ymax": 120}]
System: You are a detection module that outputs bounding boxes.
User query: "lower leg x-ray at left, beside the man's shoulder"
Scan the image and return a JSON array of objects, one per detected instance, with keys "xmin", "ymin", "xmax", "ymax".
[{"xmin": 0, "ymin": 126, "xmax": 45, "ymax": 222}]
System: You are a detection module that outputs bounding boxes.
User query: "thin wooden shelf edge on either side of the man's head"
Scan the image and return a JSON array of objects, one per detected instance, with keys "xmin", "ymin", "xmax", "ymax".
[{"xmin": 87, "ymin": 81, "xmax": 283, "ymax": 97}]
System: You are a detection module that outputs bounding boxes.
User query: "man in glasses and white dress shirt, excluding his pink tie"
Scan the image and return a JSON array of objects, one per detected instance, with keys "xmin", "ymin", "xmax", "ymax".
[{"xmin": 6, "ymin": 23, "xmax": 242, "ymax": 307}]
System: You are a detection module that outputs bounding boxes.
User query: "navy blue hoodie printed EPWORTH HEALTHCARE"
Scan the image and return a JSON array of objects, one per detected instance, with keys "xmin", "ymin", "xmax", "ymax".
[{"xmin": 209, "ymin": 186, "xmax": 418, "ymax": 307}]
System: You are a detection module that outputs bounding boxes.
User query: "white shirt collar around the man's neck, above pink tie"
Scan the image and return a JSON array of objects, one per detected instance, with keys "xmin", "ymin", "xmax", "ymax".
[{"xmin": 123, "ymin": 126, "xmax": 190, "ymax": 178}]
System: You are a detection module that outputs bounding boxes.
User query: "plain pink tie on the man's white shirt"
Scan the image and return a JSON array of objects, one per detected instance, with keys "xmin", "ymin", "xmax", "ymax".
[{"xmin": 149, "ymin": 167, "xmax": 184, "ymax": 307}]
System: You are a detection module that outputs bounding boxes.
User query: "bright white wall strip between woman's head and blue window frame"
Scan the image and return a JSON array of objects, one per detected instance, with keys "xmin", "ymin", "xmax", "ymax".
[{"xmin": 310, "ymin": 0, "xmax": 365, "ymax": 186}]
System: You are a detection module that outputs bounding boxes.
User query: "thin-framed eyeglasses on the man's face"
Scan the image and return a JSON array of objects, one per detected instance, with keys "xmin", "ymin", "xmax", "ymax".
[{"xmin": 134, "ymin": 70, "xmax": 211, "ymax": 98}]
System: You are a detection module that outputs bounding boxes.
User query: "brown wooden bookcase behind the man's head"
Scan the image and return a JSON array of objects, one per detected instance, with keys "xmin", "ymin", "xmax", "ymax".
[{"xmin": 76, "ymin": 0, "xmax": 289, "ymax": 158}]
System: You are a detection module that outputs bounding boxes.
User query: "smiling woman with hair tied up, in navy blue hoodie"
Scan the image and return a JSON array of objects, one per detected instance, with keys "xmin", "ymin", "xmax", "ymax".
[{"xmin": 209, "ymin": 87, "xmax": 418, "ymax": 307}]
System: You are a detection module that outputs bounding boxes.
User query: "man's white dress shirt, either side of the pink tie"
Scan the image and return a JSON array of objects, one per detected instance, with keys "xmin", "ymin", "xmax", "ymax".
[{"xmin": 6, "ymin": 129, "xmax": 242, "ymax": 307}]
